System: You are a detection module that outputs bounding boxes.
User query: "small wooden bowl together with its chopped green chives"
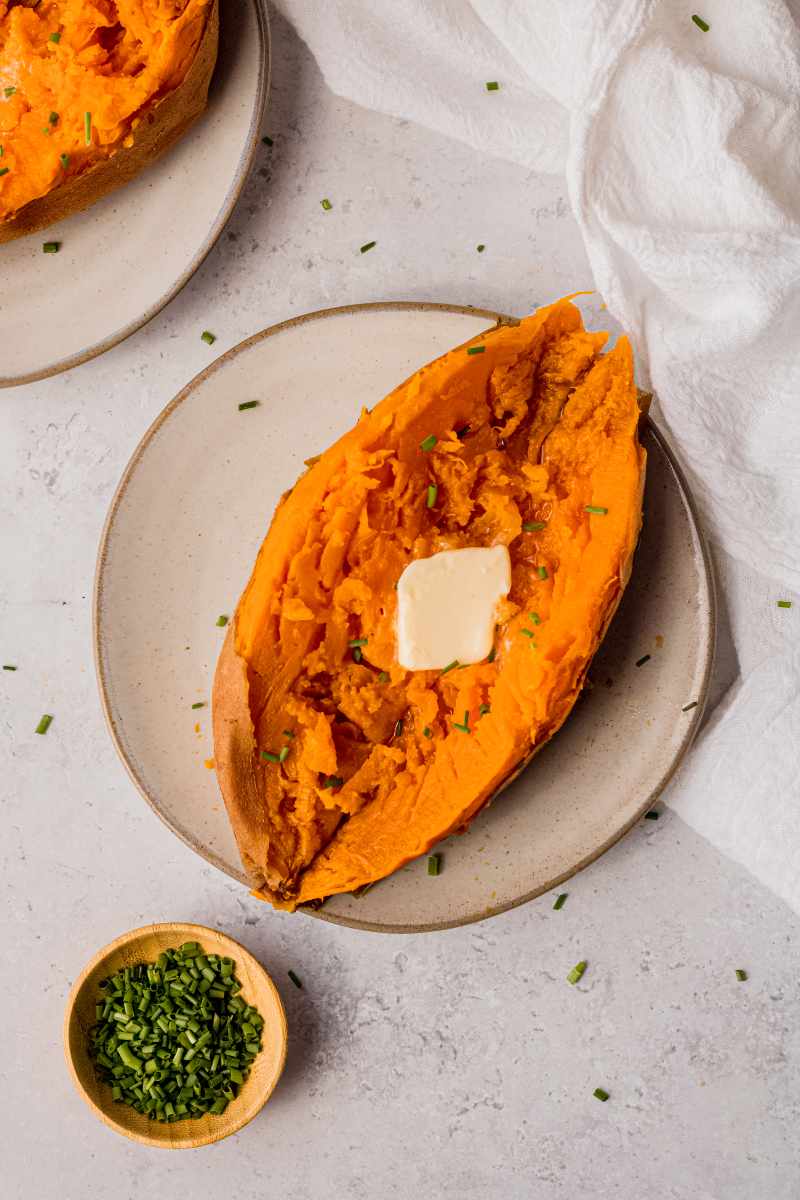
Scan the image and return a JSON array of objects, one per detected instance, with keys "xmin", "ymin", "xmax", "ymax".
[{"xmin": 64, "ymin": 923, "xmax": 287, "ymax": 1150}]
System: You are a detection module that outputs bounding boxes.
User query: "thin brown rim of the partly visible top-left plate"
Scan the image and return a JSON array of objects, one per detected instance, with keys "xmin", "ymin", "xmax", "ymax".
[{"xmin": 0, "ymin": 0, "xmax": 272, "ymax": 388}]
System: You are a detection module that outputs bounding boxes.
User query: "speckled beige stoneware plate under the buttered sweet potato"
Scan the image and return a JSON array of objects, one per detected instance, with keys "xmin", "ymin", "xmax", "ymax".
[{"xmin": 95, "ymin": 297, "xmax": 715, "ymax": 931}]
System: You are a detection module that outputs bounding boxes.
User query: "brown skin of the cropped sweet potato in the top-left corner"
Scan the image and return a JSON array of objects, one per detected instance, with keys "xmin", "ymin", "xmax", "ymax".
[{"xmin": 0, "ymin": 0, "xmax": 219, "ymax": 244}]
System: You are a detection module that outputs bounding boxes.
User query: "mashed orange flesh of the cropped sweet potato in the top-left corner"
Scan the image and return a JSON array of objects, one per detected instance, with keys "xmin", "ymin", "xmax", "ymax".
[{"xmin": 0, "ymin": 0, "xmax": 211, "ymax": 221}]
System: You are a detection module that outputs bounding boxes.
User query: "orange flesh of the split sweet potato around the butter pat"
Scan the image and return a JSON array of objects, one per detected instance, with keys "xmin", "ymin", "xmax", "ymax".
[{"xmin": 213, "ymin": 300, "xmax": 645, "ymax": 908}]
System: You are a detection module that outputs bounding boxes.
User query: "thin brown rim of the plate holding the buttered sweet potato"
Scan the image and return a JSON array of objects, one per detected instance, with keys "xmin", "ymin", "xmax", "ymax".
[{"xmin": 91, "ymin": 295, "xmax": 718, "ymax": 934}]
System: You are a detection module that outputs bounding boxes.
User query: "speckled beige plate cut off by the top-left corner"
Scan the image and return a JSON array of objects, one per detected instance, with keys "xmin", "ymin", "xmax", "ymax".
[{"xmin": 0, "ymin": 0, "xmax": 270, "ymax": 388}]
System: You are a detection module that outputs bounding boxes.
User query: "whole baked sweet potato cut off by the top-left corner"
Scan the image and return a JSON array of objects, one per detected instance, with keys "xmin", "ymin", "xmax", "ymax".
[{"xmin": 0, "ymin": 0, "xmax": 218, "ymax": 242}]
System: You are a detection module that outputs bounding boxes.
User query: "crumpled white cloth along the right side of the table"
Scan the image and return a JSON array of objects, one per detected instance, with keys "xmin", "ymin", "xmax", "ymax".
[{"xmin": 273, "ymin": 0, "xmax": 800, "ymax": 908}]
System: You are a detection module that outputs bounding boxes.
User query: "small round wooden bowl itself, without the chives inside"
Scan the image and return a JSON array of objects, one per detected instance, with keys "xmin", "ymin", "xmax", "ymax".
[{"xmin": 64, "ymin": 922, "xmax": 287, "ymax": 1150}]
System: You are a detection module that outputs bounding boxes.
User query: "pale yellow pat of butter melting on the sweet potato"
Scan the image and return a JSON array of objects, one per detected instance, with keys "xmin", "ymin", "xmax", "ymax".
[{"xmin": 397, "ymin": 546, "xmax": 511, "ymax": 671}]
